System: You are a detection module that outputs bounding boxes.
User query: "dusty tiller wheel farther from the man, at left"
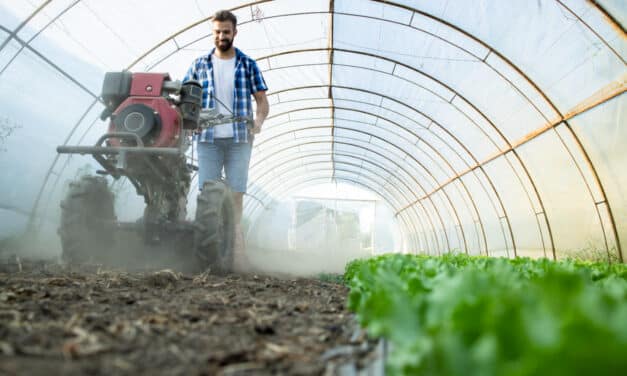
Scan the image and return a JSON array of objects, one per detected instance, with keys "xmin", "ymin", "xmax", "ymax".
[{"xmin": 59, "ymin": 176, "xmax": 116, "ymax": 263}]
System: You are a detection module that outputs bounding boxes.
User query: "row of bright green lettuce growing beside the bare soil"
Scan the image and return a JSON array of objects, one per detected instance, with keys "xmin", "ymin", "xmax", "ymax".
[{"xmin": 344, "ymin": 255, "xmax": 627, "ymax": 376}]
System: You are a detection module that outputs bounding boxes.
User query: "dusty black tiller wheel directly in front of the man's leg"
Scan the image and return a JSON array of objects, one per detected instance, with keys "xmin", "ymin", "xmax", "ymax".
[{"xmin": 194, "ymin": 181, "xmax": 235, "ymax": 273}]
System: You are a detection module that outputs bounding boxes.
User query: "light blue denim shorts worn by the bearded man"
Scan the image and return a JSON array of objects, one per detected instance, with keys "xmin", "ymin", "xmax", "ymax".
[{"xmin": 196, "ymin": 138, "xmax": 253, "ymax": 193}]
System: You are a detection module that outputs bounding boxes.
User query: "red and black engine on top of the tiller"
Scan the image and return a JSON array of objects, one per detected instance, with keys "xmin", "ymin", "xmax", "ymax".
[{"xmin": 101, "ymin": 71, "xmax": 202, "ymax": 147}]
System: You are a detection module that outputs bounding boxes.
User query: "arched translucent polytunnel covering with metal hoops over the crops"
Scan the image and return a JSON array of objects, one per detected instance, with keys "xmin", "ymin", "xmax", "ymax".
[{"xmin": 0, "ymin": 0, "xmax": 627, "ymax": 261}]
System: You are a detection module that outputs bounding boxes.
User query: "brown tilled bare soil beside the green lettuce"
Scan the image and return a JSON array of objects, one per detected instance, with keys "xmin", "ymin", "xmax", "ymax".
[{"xmin": 0, "ymin": 260, "xmax": 374, "ymax": 375}]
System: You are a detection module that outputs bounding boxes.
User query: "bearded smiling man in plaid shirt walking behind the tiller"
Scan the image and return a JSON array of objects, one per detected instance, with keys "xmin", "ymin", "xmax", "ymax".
[{"xmin": 183, "ymin": 10, "xmax": 269, "ymax": 267}]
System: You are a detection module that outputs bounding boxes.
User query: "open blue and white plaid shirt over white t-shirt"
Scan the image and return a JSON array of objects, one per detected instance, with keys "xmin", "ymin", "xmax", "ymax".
[{"xmin": 183, "ymin": 48, "xmax": 268, "ymax": 143}]
